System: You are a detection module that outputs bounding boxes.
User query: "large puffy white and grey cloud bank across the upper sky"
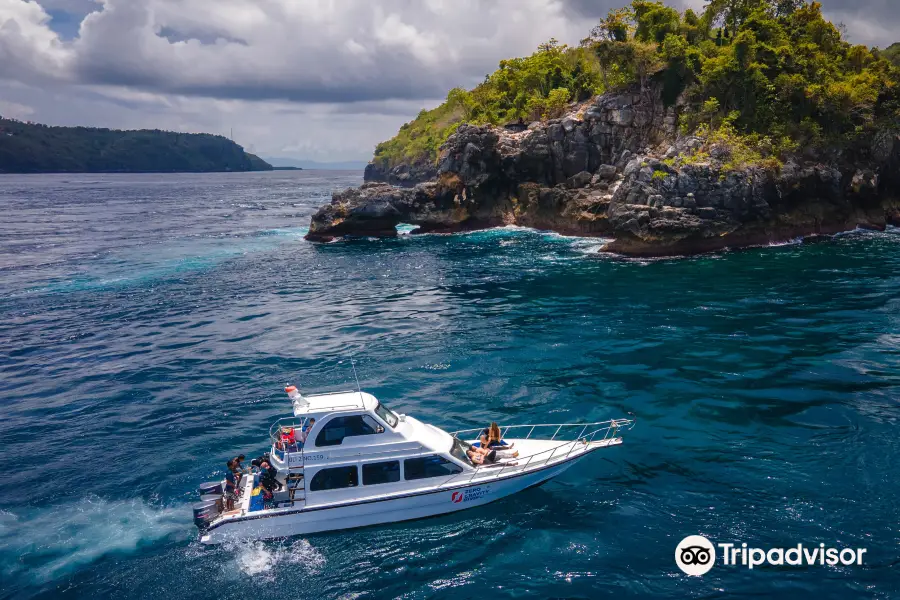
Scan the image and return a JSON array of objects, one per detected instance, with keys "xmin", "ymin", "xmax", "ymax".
[{"xmin": 0, "ymin": 0, "xmax": 587, "ymax": 102}]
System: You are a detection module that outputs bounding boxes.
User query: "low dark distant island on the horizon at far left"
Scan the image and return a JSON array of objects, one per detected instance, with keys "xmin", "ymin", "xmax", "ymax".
[{"xmin": 0, "ymin": 117, "xmax": 272, "ymax": 173}]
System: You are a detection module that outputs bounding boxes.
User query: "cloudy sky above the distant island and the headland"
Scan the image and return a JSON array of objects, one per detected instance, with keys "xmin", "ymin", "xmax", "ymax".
[{"xmin": 0, "ymin": 0, "xmax": 900, "ymax": 161}]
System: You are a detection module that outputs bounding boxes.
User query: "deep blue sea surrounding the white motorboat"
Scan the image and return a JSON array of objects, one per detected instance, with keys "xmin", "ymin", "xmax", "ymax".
[{"xmin": 0, "ymin": 172, "xmax": 900, "ymax": 600}]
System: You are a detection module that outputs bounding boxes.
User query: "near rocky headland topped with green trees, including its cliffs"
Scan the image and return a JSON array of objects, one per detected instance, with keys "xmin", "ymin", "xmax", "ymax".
[{"xmin": 306, "ymin": 0, "xmax": 900, "ymax": 256}]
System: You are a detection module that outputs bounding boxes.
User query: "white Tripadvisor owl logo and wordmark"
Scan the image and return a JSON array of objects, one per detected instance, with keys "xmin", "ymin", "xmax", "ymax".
[{"xmin": 675, "ymin": 535, "xmax": 866, "ymax": 575}]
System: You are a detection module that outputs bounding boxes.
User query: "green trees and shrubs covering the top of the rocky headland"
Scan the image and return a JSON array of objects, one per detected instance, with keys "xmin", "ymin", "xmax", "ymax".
[{"xmin": 374, "ymin": 0, "xmax": 900, "ymax": 168}]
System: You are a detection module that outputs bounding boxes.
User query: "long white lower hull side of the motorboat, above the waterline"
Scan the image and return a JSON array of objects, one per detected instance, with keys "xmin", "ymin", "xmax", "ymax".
[{"xmin": 200, "ymin": 440, "xmax": 600, "ymax": 544}]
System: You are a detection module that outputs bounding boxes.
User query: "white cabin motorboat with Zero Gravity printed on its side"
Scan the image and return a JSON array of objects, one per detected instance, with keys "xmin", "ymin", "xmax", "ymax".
[{"xmin": 194, "ymin": 386, "xmax": 634, "ymax": 544}]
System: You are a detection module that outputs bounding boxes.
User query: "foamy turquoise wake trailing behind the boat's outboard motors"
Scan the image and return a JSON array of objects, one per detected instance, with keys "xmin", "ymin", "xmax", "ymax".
[{"xmin": 0, "ymin": 497, "xmax": 193, "ymax": 583}]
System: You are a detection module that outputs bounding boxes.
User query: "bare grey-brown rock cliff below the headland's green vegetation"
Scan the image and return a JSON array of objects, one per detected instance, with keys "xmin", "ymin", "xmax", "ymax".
[{"xmin": 307, "ymin": 84, "xmax": 900, "ymax": 256}]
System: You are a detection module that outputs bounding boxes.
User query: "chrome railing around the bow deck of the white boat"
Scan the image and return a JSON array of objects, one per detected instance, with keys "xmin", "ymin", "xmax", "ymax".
[{"xmin": 441, "ymin": 419, "xmax": 634, "ymax": 487}]
